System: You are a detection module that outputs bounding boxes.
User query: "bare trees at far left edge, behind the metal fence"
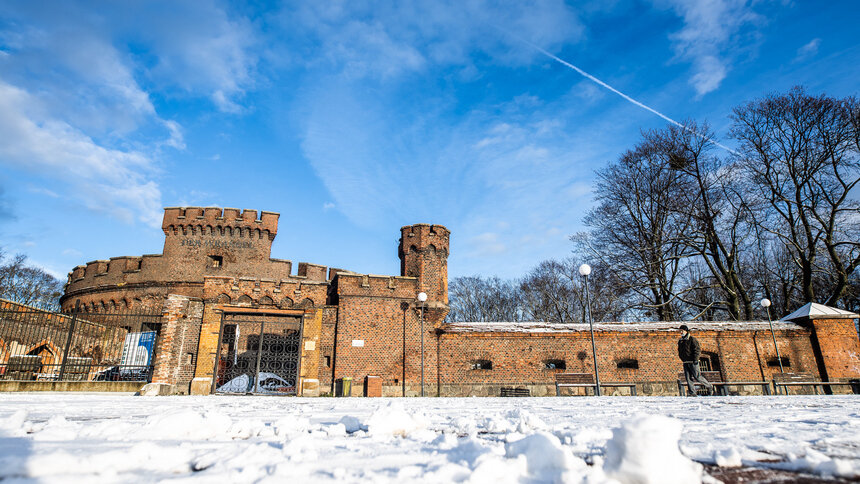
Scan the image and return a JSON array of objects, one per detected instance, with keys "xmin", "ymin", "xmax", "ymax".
[{"xmin": 0, "ymin": 251, "xmax": 63, "ymax": 310}]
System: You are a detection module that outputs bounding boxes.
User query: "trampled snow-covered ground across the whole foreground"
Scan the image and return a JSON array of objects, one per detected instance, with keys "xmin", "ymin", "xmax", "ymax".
[{"xmin": 0, "ymin": 393, "xmax": 860, "ymax": 484}]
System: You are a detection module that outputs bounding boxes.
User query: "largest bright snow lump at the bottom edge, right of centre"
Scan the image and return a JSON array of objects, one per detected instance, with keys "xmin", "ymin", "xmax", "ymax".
[{"xmin": 603, "ymin": 415, "xmax": 702, "ymax": 484}]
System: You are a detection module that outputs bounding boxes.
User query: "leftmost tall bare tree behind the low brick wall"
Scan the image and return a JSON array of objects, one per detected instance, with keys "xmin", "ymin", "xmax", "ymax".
[{"xmin": 572, "ymin": 138, "xmax": 692, "ymax": 321}]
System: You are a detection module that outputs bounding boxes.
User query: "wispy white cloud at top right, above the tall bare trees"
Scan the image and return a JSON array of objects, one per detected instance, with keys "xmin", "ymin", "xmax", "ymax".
[{"xmin": 655, "ymin": 0, "xmax": 761, "ymax": 97}]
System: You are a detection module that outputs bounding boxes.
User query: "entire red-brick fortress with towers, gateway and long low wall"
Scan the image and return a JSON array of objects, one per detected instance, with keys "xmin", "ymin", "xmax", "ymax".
[{"xmin": 61, "ymin": 207, "xmax": 860, "ymax": 396}]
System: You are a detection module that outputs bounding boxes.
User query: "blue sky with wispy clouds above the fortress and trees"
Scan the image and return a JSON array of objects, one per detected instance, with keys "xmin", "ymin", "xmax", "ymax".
[{"xmin": 0, "ymin": 0, "xmax": 860, "ymax": 277}]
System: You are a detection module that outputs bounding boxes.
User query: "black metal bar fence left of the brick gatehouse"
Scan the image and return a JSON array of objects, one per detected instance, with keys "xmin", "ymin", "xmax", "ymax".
[{"xmin": 0, "ymin": 301, "xmax": 161, "ymax": 382}]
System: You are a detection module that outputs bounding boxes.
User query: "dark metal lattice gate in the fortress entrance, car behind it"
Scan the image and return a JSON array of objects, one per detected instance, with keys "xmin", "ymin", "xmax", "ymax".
[{"xmin": 215, "ymin": 313, "xmax": 302, "ymax": 395}]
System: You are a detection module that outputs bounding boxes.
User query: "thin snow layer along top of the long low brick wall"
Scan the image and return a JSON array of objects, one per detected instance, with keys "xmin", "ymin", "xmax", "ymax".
[{"xmin": 441, "ymin": 321, "xmax": 803, "ymax": 333}]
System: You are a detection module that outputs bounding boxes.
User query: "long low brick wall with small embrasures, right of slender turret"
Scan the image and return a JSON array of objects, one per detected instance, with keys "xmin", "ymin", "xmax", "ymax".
[{"xmin": 438, "ymin": 323, "xmax": 817, "ymax": 396}]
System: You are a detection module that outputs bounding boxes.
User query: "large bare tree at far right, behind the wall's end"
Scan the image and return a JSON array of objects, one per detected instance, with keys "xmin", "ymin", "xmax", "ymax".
[{"xmin": 732, "ymin": 88, "xmax": 860, "ymax": 308}]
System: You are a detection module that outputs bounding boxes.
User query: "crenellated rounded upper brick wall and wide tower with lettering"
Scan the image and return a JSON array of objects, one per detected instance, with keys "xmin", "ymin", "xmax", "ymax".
[{"xmin": 60, "ymin": 207, "xmax": 328, "ymax": 312}]
